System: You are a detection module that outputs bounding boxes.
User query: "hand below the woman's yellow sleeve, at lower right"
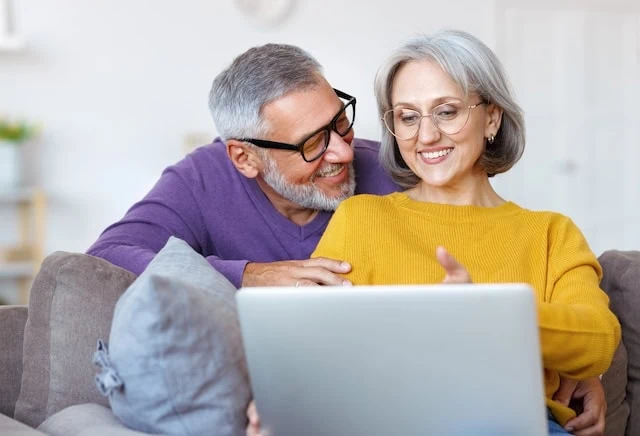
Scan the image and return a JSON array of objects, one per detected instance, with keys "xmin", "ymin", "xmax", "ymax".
[{"xmin": 553, "ymin": 377, "xmax": 607, "ymax": 436}]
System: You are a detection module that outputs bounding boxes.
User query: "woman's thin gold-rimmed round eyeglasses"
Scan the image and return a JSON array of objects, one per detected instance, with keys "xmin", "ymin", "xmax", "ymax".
[{"xmin": 382, "ymin": 100, "xmax": 487, "ymax": 140}]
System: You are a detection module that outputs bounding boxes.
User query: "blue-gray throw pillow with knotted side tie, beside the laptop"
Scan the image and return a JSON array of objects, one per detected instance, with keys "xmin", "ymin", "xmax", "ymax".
[{"xmin": 94, "ymin": 238, "xmax": 250, "ymax": 435}]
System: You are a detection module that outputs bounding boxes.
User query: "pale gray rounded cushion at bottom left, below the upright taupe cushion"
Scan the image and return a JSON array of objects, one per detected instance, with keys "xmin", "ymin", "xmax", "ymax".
[{"xmin": 38, "ymin": 403, "xmax": 146, "ymax": 436}]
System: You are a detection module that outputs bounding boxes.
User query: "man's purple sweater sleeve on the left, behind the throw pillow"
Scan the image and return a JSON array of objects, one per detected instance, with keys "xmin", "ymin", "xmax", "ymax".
[{"xmin": 87, "ymin": 166, "xmax": 247, "ymax": 287}]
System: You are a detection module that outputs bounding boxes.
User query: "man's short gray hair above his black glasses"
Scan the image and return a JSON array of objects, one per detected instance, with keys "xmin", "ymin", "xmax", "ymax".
[{"xmin": 209, "ymin": 44, "xmax": 322, "ymax": 140}]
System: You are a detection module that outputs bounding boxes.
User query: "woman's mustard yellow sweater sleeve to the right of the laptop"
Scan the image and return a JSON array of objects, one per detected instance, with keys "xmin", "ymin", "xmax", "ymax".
[{"xmin": 538, "ymin": 217, "xmax": 620, "ymax": 379}]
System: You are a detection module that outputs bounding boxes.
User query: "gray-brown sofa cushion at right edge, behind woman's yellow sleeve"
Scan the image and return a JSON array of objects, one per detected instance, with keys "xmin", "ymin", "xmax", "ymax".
[{"xmin": 598, "ymin": 250, "xmax": 640, "ymax": 436}]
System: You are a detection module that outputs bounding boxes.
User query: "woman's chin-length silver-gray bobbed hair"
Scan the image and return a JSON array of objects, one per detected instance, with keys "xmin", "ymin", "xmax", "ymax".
[{"xmin": 375, "ymin": 30, "xmax": 525, "ymax": 188}]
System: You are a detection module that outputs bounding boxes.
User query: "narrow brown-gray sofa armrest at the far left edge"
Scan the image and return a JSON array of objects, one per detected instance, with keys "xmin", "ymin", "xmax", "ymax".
[{"xmin": 0, "ymin": 306, "xmax": 27, "ymax": 418}]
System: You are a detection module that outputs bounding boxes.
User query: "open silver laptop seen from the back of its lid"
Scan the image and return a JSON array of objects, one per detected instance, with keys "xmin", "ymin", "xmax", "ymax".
[{"xmin": 236, "ymin": 284, "xmax": 547, "ymax": 436}]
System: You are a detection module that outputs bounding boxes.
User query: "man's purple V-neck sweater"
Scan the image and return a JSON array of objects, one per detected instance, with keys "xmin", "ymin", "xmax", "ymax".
[{"xmin": 87, "ymin": 139, "xmax": 398, "ymax": 287}]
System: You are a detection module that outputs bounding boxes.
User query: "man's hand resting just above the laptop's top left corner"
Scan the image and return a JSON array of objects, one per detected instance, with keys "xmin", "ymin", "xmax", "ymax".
[{"xmin": 242, "ymin": 257, "xmax": 351, "ymax": 286}]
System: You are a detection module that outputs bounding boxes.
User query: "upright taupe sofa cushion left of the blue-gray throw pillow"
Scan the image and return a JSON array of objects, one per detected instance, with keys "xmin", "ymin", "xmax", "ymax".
[{"xmin": 15, "ymin": 252, "xmax": 135, "ymax": 427}]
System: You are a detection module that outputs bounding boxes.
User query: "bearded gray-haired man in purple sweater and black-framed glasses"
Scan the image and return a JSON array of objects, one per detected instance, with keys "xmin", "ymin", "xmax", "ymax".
[{"xmin": 88, "ymin": 44, "xmax": 604, "ymax": 436}]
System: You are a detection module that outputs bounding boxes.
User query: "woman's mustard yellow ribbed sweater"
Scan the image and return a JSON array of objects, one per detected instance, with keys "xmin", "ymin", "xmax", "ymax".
[{"xmin": 312, "ymin": 193, "xmax": 620, "ymax": 425}]
